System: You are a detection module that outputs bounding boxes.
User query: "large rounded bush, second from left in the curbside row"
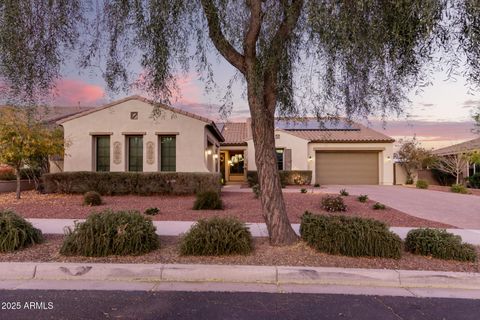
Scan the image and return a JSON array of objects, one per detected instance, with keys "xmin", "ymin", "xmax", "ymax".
[{"xmin": 60, "ymin": 210, "xmax": 160, "ymax": 257}]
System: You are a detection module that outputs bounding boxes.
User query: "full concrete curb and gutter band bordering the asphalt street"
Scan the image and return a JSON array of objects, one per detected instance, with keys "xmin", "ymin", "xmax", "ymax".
[{"xmin": 0, "ymin": 262, "xmax": 480, "ymax": 299}]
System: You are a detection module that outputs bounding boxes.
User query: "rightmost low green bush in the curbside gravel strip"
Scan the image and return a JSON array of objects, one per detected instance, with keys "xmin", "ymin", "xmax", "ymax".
[{"xmin": 405, "ymin": 228, "xmax": 477, "ymax": 261}]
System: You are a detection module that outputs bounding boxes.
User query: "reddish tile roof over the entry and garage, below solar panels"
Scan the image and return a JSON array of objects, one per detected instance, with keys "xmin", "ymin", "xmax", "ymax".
[{"xmin": 222, "ymin": 122, "xmax": 395, "ymax": 145}]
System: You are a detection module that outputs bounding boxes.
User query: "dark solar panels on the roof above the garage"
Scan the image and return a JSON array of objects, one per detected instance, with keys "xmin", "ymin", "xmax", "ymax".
[{"xmin": 275, "ymin": 118, "xmax": 360, "ymax": 131}]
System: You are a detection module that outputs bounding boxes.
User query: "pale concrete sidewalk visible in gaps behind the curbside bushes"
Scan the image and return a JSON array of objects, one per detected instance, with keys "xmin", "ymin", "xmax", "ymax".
[{"xmin": 27, "ymin": 219, "xmax": 480, "ymax": 245}]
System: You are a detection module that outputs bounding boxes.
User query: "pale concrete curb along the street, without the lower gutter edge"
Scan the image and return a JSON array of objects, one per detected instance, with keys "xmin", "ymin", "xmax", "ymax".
[{"xmin": 0, "ymin": 262, "xmax": 480, "ymax": 290}]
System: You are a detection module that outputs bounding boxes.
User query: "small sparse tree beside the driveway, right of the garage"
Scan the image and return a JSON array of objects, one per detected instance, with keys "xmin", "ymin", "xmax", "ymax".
[{"xmin": 395, "ymin": 137, "xmax": 432, "ymax": 182}]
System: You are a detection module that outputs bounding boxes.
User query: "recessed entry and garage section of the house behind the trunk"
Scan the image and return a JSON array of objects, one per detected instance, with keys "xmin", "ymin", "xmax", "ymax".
[{"xmin": 220, "ymin": 118, "xmax": 394, "ymax": 185}]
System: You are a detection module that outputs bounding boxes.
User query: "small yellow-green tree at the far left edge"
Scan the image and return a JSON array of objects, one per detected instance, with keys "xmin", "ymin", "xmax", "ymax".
[{"xmin": 0, "ymin": 108, "xmax": 63, "ymax": 199}]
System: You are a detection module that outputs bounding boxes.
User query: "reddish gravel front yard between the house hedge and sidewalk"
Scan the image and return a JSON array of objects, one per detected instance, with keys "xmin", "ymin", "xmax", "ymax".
[{"xmin": 0, "ymin": 191, "xmax": 452, "ymax": 228}]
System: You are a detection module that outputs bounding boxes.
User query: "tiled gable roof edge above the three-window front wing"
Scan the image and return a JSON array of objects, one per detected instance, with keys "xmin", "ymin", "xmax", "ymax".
[{"xmin": 56, "ymin": 95, "xmax": 225, "ymax": 142}]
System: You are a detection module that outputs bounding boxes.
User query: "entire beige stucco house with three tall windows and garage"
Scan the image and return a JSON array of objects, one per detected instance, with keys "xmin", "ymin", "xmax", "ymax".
[{"xmin": 57, "ymin": 96, "xmax": 394, "ymax": 185}]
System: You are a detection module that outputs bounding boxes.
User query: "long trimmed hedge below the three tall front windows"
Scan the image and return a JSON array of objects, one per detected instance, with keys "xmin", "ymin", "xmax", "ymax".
[{"xmin": 42, "ymin": 172, "xmax": 222, "ymax": 196}]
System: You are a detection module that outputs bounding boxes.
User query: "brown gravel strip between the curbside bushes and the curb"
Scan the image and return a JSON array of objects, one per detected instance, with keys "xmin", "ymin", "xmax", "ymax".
[{"xmin": 0, "ymin": 235, "xmax": 480, "ymax": 272}]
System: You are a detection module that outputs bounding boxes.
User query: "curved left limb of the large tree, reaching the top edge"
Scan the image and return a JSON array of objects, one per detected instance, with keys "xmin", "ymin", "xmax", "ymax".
[{"xmin": 201, "ymin": 0, "xmax": 245, "ymax": 74}]
